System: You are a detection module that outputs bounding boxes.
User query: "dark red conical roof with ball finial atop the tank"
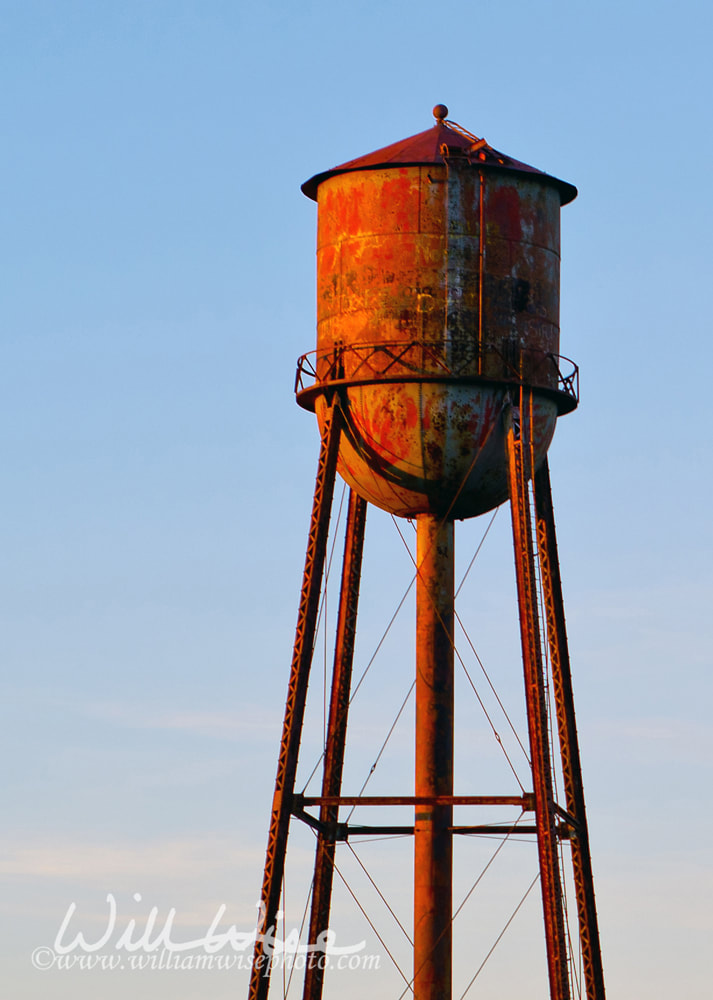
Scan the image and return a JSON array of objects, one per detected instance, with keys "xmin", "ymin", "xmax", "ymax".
[{"xmin": 302, "ymin": 104, "xmax": 577, "ymax": 205}]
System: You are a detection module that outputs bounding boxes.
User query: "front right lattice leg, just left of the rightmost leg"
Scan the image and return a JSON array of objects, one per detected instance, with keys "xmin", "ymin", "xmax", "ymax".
[{"xmin": 506, "ymin": 408, "xmax": 570, "ymax": 1000}]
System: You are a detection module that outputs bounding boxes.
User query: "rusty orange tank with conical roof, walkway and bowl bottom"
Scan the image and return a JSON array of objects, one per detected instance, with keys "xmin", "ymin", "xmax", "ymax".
[{"xmin": 296, "ymin": 105, "xmax": 577, "ymax": 518}]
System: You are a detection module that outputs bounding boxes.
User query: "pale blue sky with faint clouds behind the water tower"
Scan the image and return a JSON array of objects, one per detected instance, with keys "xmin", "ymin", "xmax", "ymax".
[{"xmin": 0, "ymin": 0, "xmax": 713, "ymax": 1000}]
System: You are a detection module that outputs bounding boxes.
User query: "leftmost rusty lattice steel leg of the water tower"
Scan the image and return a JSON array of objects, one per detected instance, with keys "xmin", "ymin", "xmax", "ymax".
[{"xmin": 248, "ymin": 402, "xmax": 341, "ymax": 1000}]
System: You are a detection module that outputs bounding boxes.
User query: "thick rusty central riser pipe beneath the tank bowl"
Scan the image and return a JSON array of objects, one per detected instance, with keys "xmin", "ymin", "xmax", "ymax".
[{"xmin": 414, "ymin": 514, "xmax": 454, "ymax": 1000}]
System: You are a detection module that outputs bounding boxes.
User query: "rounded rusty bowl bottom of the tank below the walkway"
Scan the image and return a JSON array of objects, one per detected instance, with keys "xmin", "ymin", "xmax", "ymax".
[{"xmin": 315, "ymin": 382, "xmax": 557, "ymax": 519}]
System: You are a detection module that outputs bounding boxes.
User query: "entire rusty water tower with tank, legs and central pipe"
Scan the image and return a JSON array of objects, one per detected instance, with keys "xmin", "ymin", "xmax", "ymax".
[{"xmin": 250, "ymin": 105, "xmax": 604, "ymax": 1000}]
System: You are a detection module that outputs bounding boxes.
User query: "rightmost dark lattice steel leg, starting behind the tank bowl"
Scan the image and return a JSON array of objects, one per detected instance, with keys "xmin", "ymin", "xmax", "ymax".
[{"xmin": 535, "ymin": 459, "xmax": 604, "ymax": 1000}]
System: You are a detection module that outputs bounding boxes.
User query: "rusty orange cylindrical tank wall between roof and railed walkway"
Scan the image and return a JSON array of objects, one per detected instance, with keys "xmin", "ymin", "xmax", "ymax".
[{"xmin": 317, "ymin": 157, "xmax": 560, "ymax": 366}]
